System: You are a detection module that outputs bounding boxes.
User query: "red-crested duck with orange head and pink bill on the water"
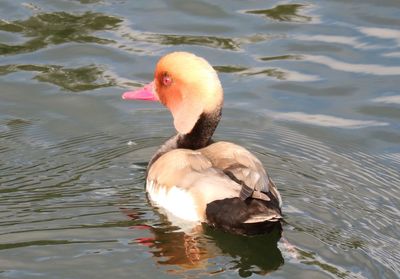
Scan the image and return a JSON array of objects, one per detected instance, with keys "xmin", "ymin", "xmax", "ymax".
[{"xmin": 122, "ymin": 51, "xmax": 283, "ymax": 235}]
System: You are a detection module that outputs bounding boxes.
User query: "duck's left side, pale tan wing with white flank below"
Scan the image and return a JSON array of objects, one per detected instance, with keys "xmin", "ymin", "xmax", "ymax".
[{"xmin": 146, "ymin": 149, "xmax": 241, "ymax": 221}]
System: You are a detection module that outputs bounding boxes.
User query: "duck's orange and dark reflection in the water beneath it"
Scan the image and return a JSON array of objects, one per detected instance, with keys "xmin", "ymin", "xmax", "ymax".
[{"xmin": 124, "ymin": 210, "xmax": 284, "ymax": 277}]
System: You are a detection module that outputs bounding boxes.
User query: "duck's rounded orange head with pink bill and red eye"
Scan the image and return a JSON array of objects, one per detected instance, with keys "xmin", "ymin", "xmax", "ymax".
[{"xmin": 122, "ymin": 52, "xmax": 223, "ymax": 134}]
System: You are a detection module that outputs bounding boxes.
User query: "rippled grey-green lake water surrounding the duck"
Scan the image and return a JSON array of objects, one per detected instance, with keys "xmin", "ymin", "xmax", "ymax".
[{"xmin": 0, "ymin": 0, "xmax": 400, "ymax": 278}]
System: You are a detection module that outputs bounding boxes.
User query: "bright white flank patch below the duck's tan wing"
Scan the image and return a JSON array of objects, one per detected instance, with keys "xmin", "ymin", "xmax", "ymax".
[{"xmin": 146, "ymin": 181, "xmax": 201, "ymax": 222}]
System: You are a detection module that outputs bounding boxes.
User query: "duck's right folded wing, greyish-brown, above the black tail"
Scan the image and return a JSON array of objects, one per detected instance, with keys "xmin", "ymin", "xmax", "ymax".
[{"xmin": 200, "ymin": 141, "xmax": 282, "ymax": 206}]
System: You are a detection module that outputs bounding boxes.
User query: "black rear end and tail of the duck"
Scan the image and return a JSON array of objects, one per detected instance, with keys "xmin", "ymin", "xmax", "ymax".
[{"xmin": 206, "ymin": 193, "xmax": 282, "ymax": 235}]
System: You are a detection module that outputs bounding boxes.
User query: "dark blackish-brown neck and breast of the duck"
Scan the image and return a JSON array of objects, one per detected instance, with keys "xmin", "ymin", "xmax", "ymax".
[{"xmin": 147, "ymin": 107, "xmax": 221, "ymax": 169}]
